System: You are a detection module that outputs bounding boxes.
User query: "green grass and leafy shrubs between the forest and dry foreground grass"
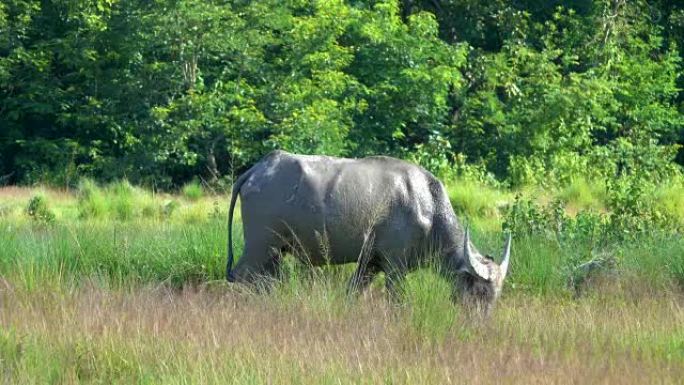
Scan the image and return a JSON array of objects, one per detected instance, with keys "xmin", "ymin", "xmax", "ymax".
[{"xmin": 0, "ymin": 179, "xmax": 684, "ymax": 295}]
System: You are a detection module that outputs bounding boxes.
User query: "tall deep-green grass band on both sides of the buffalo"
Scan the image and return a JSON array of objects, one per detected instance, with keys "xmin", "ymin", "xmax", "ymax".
[{"xmin": 0, "ymin": 216, "xmax": 684, "ymax": 296}]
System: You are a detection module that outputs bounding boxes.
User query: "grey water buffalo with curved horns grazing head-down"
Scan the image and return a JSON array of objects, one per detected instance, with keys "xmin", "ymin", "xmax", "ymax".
[{"xmin": 226, "ymin": 151, "xmax": 511, "ymax": 308}]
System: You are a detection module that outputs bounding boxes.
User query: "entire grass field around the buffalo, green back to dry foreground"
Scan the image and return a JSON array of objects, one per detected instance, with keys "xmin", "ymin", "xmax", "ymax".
[{"xmin": 0, "ymin": 182, "xmax": 684, "ymax": 384}]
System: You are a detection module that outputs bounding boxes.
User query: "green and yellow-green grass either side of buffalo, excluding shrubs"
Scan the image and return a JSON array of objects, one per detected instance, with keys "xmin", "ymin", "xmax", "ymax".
[{"xmin": 0, "ymin": 180, "xmax": 684, "ymax": 295}]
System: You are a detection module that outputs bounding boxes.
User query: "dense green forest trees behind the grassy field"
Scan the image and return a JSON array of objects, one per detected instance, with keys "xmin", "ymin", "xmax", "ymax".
[{"xmin": 0, "ymin": 0, "xmax": 684, "ymax": 188}]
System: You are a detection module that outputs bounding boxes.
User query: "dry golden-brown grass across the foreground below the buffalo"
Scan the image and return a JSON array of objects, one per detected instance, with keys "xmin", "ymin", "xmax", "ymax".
[{"xmin": 0, "ymin": 281, "xmax": 684, "ymax": 384}]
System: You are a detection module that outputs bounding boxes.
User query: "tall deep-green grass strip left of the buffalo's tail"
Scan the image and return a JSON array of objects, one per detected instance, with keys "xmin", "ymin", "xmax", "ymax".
[{"xmin": 0, "ymin": 221, "xmax": 236, "ymax": 287}]
